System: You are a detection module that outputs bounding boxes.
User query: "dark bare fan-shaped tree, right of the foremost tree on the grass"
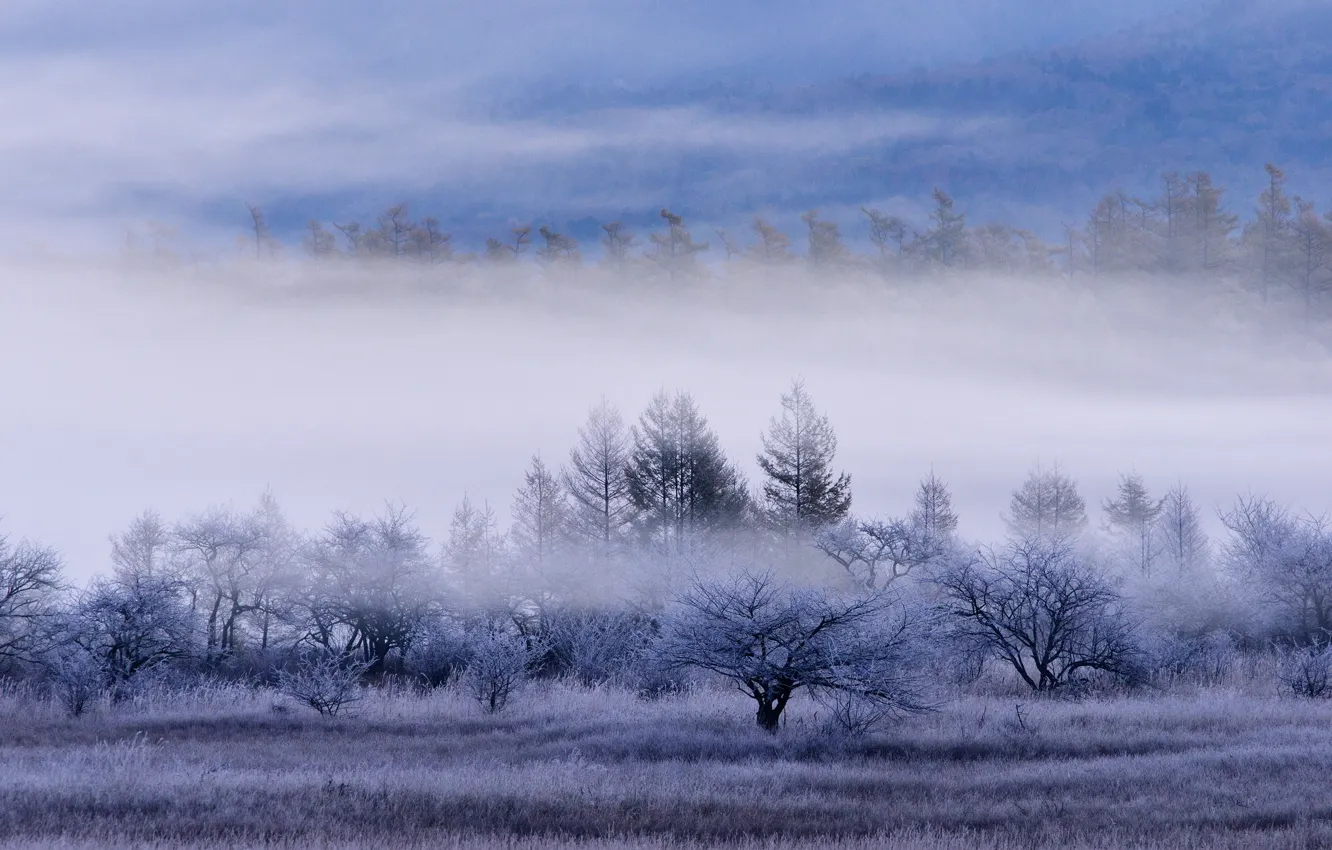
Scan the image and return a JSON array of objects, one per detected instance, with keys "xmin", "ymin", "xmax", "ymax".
[{"xmin": 935, "ymin": 536, "xmax": 1138, "ymax": 691}]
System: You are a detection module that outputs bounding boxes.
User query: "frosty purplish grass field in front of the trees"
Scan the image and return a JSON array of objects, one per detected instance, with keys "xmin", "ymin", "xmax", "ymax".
[{"xmin": 0, "ymin": 685, "xmax": 1332, "ymax": 850}]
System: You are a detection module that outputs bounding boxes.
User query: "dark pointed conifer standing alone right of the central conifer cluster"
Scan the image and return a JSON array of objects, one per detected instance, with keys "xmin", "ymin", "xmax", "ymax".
[{"xmin": 758, "ymin": 381, "xmax": 851, "ymax": 537}]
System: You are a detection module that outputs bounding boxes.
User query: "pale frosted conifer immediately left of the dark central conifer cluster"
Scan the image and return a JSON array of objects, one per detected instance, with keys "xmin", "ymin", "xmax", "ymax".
[{"xmin": 563, "ymin": 398, "xmax": 635, "ymax": 557}]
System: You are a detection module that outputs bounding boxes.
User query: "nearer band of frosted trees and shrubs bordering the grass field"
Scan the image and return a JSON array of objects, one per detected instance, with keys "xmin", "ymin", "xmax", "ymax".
[{"xmin": 0, "ymin": 382, "xmax": 1332, "ymax": 730}]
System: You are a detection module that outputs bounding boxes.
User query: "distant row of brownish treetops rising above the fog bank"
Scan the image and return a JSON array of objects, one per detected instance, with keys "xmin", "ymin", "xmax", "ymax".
[{"xmin": 210, "ymin": 165, "xmax": 1332, "ymax": 312}]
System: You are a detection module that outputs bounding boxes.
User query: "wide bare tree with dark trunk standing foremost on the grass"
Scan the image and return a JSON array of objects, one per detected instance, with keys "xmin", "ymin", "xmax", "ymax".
[{"xmin": 659, "ymin": 572, "xmax": 927, "ymax": 733}]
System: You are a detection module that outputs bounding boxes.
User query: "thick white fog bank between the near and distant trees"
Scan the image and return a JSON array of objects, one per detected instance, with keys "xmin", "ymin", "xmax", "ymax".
[{"xmin": 0, "ymin": 261, "xmax": 1332, "ymax": 577}]
